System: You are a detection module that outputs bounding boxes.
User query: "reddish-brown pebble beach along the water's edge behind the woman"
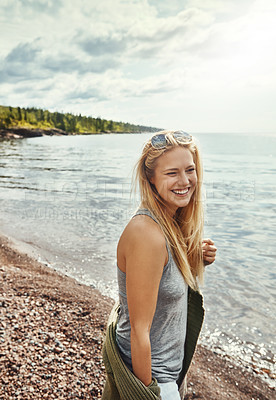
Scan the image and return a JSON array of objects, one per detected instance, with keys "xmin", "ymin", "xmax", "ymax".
[{"xmin": 0, "ymin": 237, "xmax": 276, "ymax": 400}]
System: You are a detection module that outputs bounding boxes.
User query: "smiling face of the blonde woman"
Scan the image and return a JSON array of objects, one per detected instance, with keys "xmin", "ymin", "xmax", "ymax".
[{"xmin": 150, "ymin": 146, "xmax": 197, "ymax": 215}]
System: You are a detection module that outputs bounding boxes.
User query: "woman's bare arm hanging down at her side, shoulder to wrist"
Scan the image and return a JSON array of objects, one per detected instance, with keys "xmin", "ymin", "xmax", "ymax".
[{"xmin": 125, "ymin": 217, "xmax": 167, "ymax": 386}]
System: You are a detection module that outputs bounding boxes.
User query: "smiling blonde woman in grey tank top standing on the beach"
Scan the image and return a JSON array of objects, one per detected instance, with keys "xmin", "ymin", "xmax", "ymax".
[{"xmin": 103, "ymin": 131, "xmax": 216, "ymax": 400}]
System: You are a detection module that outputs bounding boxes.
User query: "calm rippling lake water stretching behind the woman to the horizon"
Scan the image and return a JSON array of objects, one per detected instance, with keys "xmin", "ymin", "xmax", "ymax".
[{"xmin": 0, "ymin": 134, "xmax": 276, "ymax": 384}]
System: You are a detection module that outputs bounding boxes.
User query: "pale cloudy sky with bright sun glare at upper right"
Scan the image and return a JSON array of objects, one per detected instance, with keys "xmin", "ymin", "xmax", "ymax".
[{"xmin": 0, "ymin": 0, "xmax": 276, "ymax": 134}]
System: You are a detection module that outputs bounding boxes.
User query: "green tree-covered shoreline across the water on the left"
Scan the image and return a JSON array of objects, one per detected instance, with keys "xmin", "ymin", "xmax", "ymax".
[{"xmin": 0, "ymin": 106, "xmax": 158, "ymax": 134}]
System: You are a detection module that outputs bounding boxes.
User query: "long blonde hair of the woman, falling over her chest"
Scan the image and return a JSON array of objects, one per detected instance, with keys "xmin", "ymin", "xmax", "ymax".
[{"xmin": 133, "ymin": 131, "xmax": 204, "ymax": 290}]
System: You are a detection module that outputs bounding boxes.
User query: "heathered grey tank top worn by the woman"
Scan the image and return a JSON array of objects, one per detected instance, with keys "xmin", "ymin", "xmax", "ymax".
[{"xmin": 116, "ymin": 209, "xmax": 188, "ymax": 383}]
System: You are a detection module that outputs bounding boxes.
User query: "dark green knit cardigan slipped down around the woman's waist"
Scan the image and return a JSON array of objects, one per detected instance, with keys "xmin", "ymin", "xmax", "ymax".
[{"xmin": 102, "ymin": 287, "xmax": 204, "ymax": 400}]
